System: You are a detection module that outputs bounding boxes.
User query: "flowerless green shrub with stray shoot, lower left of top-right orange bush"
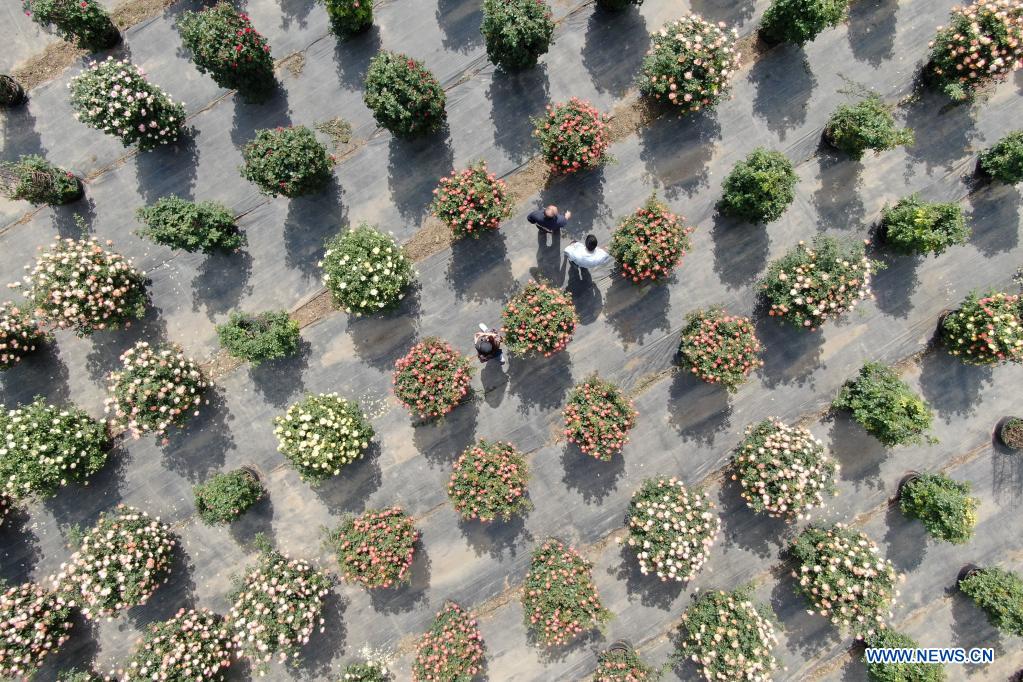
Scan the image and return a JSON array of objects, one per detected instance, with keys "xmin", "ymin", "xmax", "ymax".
[{"xmin": 825, "ymin": 95, "xmax": 914, "ymax": 161}]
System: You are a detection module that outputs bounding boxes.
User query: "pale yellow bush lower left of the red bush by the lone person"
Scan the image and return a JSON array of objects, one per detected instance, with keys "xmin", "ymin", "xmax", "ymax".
[{"xmin": 273, "ymin": 393, "xmax": 373, "ymax": 482}]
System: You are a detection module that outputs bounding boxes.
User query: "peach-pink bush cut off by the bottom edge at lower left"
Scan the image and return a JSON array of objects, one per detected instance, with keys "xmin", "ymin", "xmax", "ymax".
[{"xmin": 118, "ymin": 608, "xmax": 234, "ymax": 682}]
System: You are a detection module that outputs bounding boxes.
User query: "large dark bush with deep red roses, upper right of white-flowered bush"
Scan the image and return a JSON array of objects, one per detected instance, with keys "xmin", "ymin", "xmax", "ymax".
[{"xmin": 178, "ymin": 0, "xmax": 275, "ymax": 102}]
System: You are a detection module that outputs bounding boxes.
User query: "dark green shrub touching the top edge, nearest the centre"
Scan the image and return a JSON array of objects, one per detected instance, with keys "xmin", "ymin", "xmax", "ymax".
[{"xmin": 480, "ymin": 0, "xmax": 554, "ymax": 71}]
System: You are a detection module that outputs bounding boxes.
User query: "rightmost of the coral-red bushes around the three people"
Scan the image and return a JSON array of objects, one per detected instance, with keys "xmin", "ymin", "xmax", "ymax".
[{"xmin": 678, "ymin": 308, "xmax": 764, "ymax": 391}]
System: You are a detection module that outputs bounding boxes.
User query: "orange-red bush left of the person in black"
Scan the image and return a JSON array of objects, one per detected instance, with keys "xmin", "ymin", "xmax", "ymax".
[{"xmin": 430, "ymin": 162, "xmax": 512, "ymax": 238}]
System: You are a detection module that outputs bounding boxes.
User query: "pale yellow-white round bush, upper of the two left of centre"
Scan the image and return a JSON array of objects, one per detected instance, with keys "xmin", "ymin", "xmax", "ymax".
[{"xmin": 320, "ymin": 223, "xmax": 415, "ymax": 315}]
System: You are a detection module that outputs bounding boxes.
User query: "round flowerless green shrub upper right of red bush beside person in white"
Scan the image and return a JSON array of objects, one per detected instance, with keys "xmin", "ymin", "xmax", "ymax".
[{"xmin": 717, "ymin": 147, "xmax": 799, "ymax": 223}]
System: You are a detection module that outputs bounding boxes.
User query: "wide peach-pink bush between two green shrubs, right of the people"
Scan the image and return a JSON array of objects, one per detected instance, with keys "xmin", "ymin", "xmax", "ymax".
[{"xmin": 760, "ymin": 236, "xmax": 880, "ymax": 331}]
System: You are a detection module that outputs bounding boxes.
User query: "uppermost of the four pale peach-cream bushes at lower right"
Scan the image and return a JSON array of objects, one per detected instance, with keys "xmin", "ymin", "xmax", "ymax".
[{"xmin": 731, "ymin": 418, "xmax": 839, "ymax": 519}]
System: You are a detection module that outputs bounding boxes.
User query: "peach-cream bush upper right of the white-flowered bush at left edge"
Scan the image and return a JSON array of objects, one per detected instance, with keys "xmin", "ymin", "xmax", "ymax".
[{"xmin": 106, "ymin": 342, "xmax": 210, "ymax": 438}]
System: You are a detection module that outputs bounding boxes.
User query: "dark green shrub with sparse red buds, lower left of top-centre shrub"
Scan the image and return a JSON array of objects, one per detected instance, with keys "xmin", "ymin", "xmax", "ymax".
[{"xmin": 362, "ymin": 51, "xmax": 447, "ymax": 137}]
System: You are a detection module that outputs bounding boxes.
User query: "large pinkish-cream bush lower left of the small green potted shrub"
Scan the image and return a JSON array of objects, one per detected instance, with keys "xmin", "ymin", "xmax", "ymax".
[{"xmin": 53, "ymin": 504, "xmax": 176, "ymax": 620}]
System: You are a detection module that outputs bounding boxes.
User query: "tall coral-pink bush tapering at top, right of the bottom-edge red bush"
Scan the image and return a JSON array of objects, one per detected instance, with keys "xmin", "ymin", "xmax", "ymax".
[{"xmin": 522, "ymin": 538, "xmax": 611, "ymax": 646}]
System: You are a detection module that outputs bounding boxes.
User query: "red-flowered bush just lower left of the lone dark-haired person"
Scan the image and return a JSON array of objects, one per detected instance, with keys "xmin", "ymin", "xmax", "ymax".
[{"xmin": 392, "ymin": 337, "xmax": 473, "ymax": 419}]
